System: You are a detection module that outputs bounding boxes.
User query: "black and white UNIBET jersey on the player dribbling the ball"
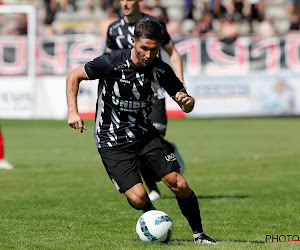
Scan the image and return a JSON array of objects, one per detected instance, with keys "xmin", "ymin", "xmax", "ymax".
[{"xmin": 84, "ymin": 49, "xmax": 184, "ymax": 148}]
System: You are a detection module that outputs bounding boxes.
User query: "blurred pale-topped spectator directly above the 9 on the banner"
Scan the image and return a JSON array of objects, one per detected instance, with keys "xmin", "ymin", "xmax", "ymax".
[{"xmin": 219, "ymin": 13, "xmax": 238, "ymax": 44}]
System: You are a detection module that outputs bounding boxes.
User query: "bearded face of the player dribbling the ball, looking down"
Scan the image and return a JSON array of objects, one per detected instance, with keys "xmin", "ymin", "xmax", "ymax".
[{"xmin": 132, "ymin": 38, "xmax": 161, "ymax": 68}]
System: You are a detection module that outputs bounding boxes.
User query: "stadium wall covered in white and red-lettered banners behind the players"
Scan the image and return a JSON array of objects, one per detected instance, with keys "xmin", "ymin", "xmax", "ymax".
[{"xmin": 0, "ymin": 35, "xmax": 300, "ymax": 119}]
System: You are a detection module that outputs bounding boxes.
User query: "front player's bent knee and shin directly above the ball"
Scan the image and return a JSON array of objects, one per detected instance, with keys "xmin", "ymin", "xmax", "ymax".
[{"xmin": 124, "ymin": 183, "xmax": 156, "ymax": 212}]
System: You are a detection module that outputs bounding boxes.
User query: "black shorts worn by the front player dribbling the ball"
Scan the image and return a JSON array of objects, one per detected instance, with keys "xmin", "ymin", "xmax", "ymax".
[{"xmin": 98, "ymin": 130, "xmax": 180, "ymax": 193}]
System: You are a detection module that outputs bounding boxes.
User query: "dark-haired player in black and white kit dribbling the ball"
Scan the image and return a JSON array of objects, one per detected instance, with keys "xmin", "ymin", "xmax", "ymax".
[{"xmin": 66, "ymin": 20, "xmax": 218, "ymax": 244}]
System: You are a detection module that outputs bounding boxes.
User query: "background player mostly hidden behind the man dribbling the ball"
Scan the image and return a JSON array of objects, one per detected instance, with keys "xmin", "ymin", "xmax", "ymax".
[{"xmin": 106, "ymin": 0, "xmax": 184, "ymax": 201}]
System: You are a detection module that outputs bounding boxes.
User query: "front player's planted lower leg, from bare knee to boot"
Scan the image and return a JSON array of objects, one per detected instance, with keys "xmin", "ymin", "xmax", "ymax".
[{"xmin": 162, "ymin": 170, "xmax": 218, "ymax": 244}]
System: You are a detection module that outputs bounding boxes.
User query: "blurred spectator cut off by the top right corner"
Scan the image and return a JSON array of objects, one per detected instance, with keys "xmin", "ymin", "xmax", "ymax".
[{"xmin": 285, "ymin": 0, "xmax": 300, "ymax": 31}]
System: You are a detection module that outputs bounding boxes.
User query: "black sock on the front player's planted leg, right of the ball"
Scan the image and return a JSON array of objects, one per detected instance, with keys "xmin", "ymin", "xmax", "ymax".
[{"xmin": 176, "ymin": 192, "xmax": 203, "ymax": 234}]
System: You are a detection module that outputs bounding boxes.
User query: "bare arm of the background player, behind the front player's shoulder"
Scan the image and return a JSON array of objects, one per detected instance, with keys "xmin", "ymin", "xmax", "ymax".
[{"xmin": 163, "ymin": 41, "xmax": 186, "ymax": 88}]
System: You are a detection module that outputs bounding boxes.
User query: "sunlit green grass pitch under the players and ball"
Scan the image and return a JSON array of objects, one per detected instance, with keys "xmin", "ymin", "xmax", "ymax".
[{"xmin": 0, "ymin": 118, "xmax": 300, "ymax": 249}]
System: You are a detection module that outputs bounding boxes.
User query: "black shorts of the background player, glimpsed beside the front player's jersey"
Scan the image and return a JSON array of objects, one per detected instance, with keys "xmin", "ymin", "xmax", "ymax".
[{"xmin": 149, "ymin": 99, "xmax": 168, "ymax": 136}]
